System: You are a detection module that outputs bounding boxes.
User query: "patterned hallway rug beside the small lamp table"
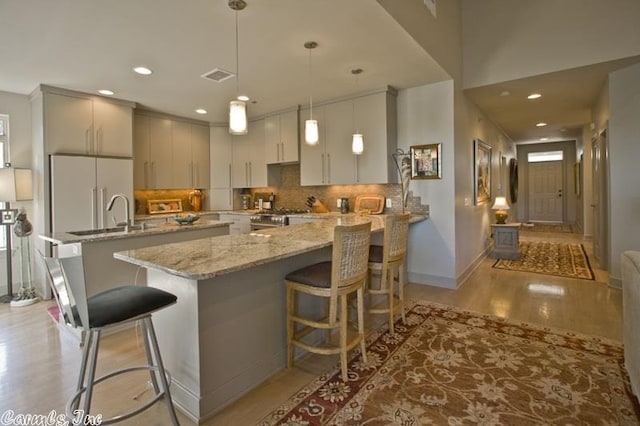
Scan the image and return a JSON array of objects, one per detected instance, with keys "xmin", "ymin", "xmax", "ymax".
[{"xmin": 493, "ymin": 241, "xmax": 594, "ymax": 280}]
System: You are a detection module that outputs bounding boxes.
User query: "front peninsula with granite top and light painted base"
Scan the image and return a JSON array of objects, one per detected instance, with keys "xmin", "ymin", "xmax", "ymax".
[{"xmin": 114, "ymin": 214, "xmax": 425, "ymax": 421}]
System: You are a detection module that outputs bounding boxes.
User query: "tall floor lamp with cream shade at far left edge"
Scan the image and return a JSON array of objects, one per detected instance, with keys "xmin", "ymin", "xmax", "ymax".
[{"xmin": 0, "ymin": 163, "xmax": 33, "ymax": 303}]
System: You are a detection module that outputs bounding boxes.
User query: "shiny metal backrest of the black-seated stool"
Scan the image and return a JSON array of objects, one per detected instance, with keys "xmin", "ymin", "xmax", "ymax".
[{"xmin": 40, "ymin": 253, "xmax": 89, "ymax": 330}]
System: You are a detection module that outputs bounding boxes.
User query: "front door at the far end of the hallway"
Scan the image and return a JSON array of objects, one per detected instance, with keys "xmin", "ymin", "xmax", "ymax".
[{"xmin": 528, "ymin": 161, "xmax": 564, "ymax": 222}]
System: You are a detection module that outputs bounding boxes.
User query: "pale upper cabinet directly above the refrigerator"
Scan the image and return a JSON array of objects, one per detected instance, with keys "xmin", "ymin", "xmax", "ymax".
[{"xmin": 43, "ymin": 87, "xmax": 134, "ymax": 157}]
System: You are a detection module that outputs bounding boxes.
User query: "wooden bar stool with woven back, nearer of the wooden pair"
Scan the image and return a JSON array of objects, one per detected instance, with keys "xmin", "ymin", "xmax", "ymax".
[{"xmin": 285, "ymin": 222, "xmax": 371, "ymax": 382}]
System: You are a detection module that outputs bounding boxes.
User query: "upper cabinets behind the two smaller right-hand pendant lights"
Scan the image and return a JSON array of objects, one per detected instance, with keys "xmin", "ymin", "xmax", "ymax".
[{"xmin": 300, "ymin": 89, "xmax": 397, "ymax": 185}]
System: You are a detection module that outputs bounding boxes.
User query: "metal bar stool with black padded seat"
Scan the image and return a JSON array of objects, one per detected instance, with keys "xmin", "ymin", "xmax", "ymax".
[{"xmin": 42, "ymin": 256, "xmax": 179, "ymax": 425}]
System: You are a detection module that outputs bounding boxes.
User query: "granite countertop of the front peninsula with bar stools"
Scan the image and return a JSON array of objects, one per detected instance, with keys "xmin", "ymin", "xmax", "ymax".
[{"xmin": 114, "ymin": 214, "xmax": 426, "ymax": 280}]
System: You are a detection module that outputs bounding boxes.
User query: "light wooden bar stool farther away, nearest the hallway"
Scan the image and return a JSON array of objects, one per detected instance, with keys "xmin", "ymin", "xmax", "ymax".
[{"xmin": 367, "ymin": 213, "xmax": 411, "ymax": 335}]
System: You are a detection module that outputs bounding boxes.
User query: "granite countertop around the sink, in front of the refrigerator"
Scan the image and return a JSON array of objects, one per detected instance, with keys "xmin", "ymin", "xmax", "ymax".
[{"xmin": 39, "ymin": 218, "xmax": 231, "ymax": 244}]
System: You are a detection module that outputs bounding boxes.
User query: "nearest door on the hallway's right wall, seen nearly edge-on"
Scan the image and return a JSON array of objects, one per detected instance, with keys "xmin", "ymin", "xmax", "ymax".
[{"xmin": 591, "ymin": 132, "xmax": 609, "ymax": 270}]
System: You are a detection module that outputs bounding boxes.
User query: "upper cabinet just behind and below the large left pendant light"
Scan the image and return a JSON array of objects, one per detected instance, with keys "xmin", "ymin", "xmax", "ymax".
[{"xmin": 231, "ymin": 119, "xmax": 267, "ymax": 188}]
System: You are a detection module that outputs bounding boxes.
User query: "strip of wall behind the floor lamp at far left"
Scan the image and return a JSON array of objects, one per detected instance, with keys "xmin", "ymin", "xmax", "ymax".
[{"xmin": 0, "ymin": 91, "xmax": 37, "ymax": 295}]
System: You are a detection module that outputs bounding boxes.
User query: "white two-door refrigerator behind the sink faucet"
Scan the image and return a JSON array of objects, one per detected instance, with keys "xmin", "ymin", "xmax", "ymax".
[{"xmin": 51, "ymin": 155, "xmax": 135, "ymax": 232}]
